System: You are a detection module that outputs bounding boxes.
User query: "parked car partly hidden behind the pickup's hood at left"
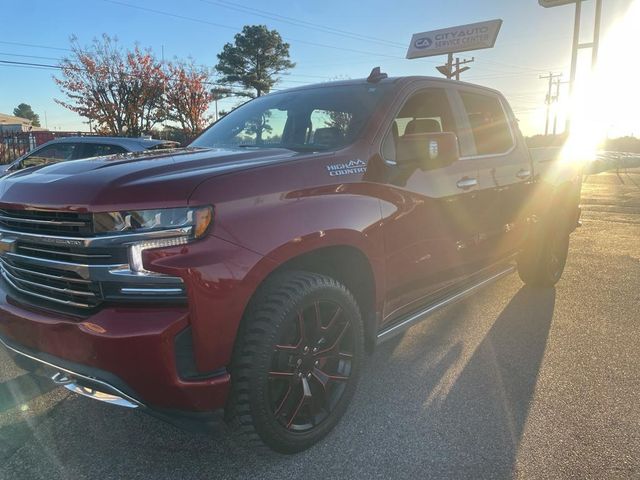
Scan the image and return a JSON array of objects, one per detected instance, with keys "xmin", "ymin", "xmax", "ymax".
[{"xmin": 0, "ymin": 136, "xmax": 178, "ymax": 176}]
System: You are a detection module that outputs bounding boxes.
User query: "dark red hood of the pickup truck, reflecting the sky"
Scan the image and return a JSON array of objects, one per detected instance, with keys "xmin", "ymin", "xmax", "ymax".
[{"xmin": 0, "ymin": 148, "xmax": 300, "ymax": 211}]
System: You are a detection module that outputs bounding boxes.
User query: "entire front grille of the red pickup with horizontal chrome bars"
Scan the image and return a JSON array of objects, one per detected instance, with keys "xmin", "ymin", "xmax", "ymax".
[{"xmin": 0, "ymin": 209, "xmax": 189, "ymax": 317}]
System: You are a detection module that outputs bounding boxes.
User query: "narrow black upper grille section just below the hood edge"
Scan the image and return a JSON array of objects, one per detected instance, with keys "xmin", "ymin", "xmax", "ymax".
[{"xmin": 0, "ymin": 209, "xmax": 93, "ymax": 236}]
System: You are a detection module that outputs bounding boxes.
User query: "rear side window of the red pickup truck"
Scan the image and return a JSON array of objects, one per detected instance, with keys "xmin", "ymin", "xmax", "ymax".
[{"xmin": 460, "ymin": 92, "xmax": 513, "ymax": 155}]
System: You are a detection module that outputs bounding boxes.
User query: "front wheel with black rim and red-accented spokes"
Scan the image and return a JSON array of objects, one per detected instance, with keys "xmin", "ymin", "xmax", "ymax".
[{"xmin": 226, "ymin": 272, "xmax": 364, "ymax": 453}]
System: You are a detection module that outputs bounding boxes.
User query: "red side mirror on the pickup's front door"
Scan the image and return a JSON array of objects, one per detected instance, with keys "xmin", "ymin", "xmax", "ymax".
[{"xmin": 396, "ymin": 132, "xmax": 460, "ymax": 170}]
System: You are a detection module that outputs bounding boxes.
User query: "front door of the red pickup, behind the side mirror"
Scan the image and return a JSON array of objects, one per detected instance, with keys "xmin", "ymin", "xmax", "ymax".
[{"xmin": 381, "ymin": 88, "xmax": 479, "ymax": 322}]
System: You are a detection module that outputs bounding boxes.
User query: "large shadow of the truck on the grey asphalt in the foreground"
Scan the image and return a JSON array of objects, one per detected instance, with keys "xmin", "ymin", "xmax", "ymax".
[{"xmin": 0, "ymin": 281, "xmax": 555, "ymax": 479}]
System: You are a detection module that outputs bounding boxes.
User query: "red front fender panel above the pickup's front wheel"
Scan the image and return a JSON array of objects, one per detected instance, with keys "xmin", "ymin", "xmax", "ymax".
[{"xmin": 214, "ymin": 184, "xmax": 385, "ymax": 308}]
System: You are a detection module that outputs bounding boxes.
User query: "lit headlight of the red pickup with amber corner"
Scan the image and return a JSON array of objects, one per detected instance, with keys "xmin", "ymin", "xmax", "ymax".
[{"xmin": 94, "ymin": 206, "xmax": 213, "ymax": 274}]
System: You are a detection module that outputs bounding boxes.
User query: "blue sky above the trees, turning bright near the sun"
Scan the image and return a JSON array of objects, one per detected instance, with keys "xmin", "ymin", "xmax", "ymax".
[{"xmin": 0, "ymin": 0, "xmax": 640, "ymax": 136}]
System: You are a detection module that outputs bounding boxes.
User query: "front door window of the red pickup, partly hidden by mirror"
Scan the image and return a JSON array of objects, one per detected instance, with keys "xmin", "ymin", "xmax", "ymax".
[{"xmin": 382, "ymin": 88, "xmax": 456, "ymax": 163}]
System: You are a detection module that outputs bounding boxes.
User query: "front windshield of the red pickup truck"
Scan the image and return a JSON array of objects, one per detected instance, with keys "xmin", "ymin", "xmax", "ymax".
[{"xmin": 190, "ymin": 84, "xmax": 389, "ymax": 151}]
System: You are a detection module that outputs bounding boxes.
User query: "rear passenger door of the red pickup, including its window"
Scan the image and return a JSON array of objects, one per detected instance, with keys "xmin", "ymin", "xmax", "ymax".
[{"xmin": 456, "ymin": 87, "xmax": 534, "ymax": 265}]
